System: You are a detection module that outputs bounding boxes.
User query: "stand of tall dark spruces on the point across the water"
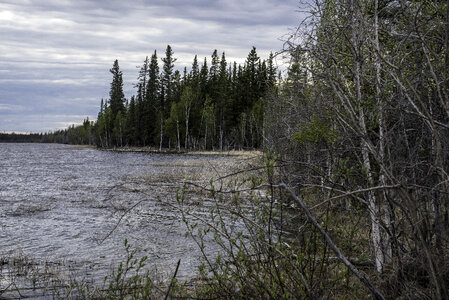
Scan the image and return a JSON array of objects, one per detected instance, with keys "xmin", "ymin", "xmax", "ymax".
[{"xmin": 91, "ymin": 45, "xmax": 278, "ymax": 150}]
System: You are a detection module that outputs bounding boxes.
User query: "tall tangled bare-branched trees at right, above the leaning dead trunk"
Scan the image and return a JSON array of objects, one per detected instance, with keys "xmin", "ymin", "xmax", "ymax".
[{"xmin": 265, "ymin": 0, "xmax": 449, "ymax": 299}]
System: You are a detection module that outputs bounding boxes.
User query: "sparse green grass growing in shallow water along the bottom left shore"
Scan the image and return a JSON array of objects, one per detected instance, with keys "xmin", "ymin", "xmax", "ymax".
[{"xmin": 0, "ymin": 240, "xmax": 184, "ymax": 300}]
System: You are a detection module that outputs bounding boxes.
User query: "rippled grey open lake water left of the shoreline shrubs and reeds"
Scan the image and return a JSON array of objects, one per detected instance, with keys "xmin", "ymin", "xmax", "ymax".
[{"xmin": 0, "ymin": 144, "xmax": 221, "ymax": 288}]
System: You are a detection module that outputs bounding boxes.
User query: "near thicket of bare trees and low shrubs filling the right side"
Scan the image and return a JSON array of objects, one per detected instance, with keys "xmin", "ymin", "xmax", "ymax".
[{"xmin": 175, "ymin": 0, "xmax": 449, "ymax": 299}]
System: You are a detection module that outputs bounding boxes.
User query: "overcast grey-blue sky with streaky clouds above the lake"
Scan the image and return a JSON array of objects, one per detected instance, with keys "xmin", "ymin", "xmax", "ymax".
[{"xmin": 0, "ymin": 0, "xmax": 299, "ymax": 132}]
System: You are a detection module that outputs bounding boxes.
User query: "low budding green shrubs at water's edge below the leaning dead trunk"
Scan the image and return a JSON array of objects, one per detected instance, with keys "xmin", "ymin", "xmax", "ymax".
[{"xmin": 178, "ymin": 151, "xmax": 368, "ymax": 299}]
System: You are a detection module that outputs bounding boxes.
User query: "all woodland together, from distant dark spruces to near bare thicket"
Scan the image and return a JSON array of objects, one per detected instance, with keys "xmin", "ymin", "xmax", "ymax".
[{"xmin": 1, "ymin": 0, "xmax": 449, "ymax": 299}]
